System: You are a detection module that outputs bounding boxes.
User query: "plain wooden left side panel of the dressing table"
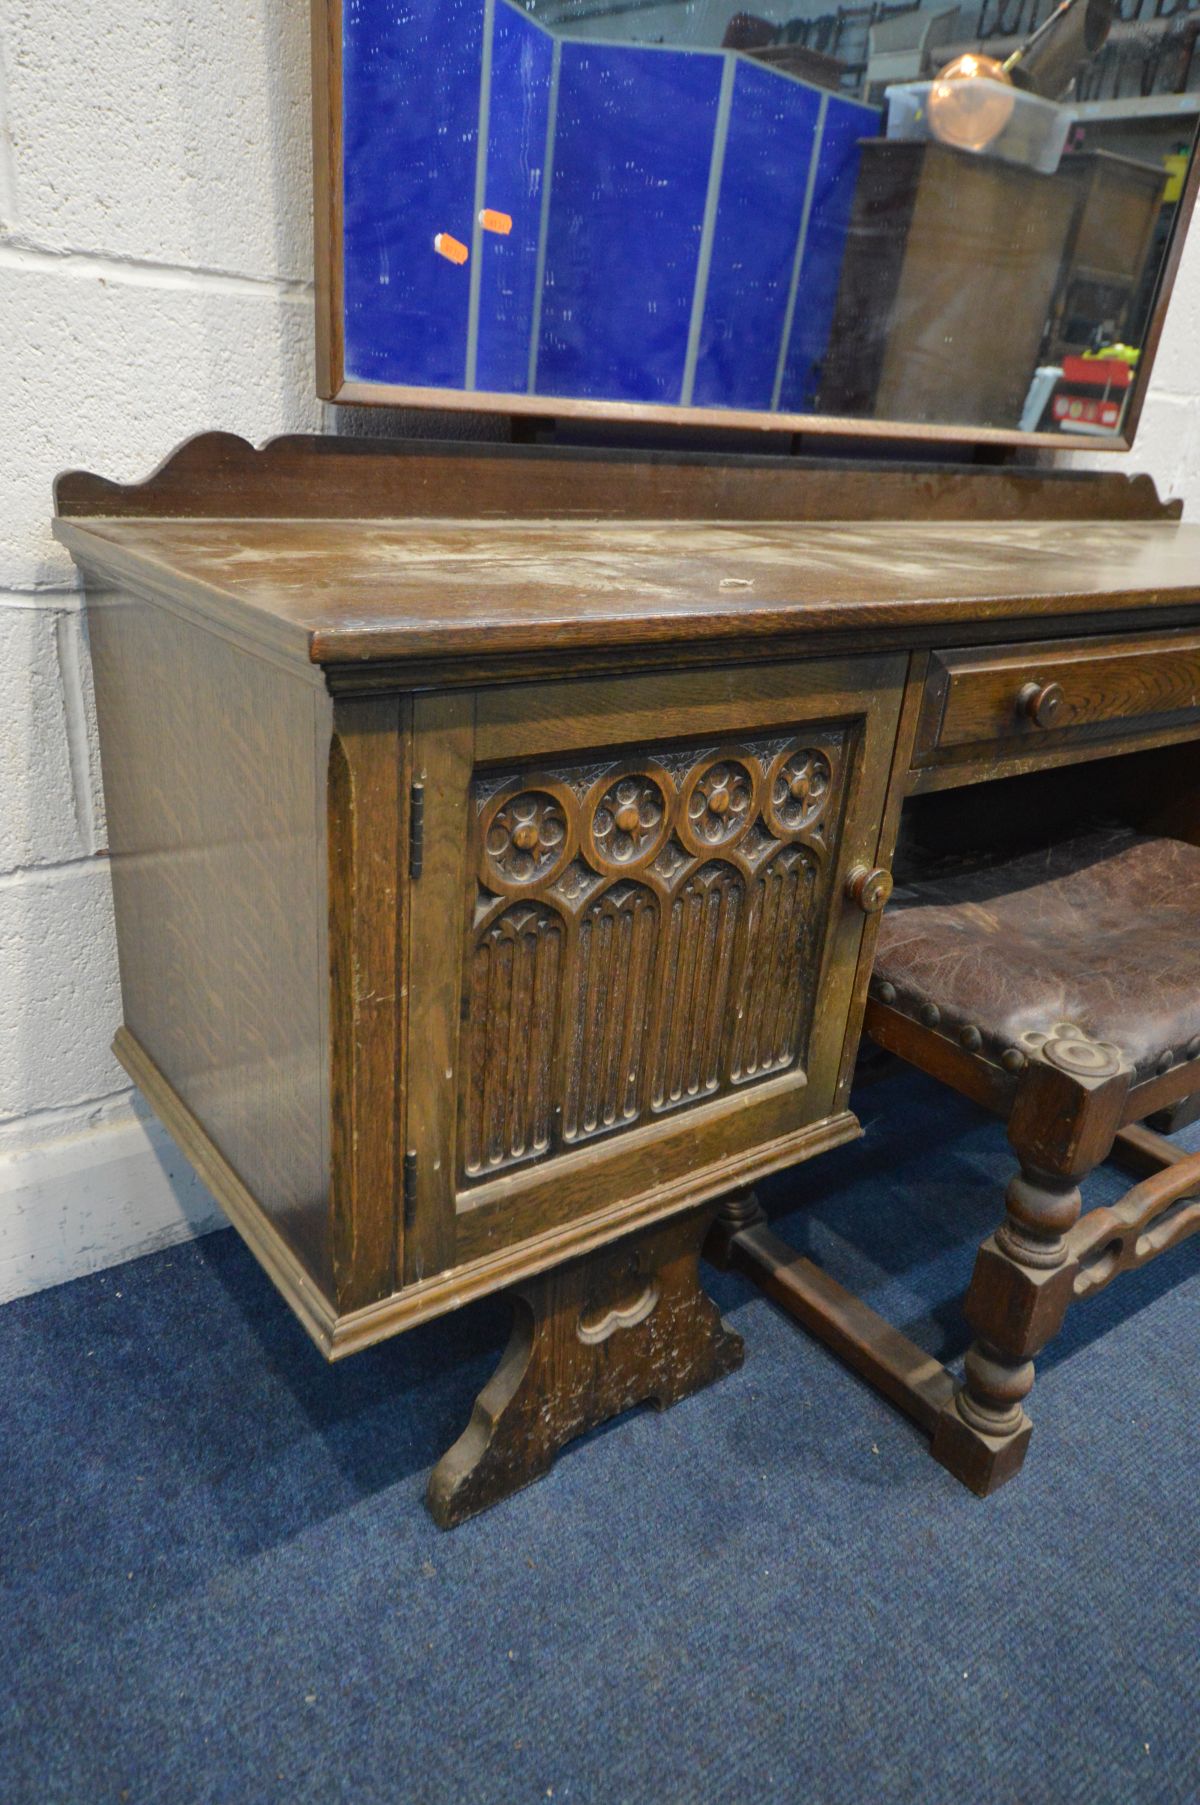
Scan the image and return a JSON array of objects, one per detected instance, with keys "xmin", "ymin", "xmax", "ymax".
[{"xmin": 88, "ymin": 577, "xmax": 332, "ymax": 1292}]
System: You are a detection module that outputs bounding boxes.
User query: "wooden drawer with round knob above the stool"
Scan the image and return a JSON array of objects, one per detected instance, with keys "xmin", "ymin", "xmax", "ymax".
[{"xmin": 915, "ymin": 632, "xmax": 1200, "ymax": 764}]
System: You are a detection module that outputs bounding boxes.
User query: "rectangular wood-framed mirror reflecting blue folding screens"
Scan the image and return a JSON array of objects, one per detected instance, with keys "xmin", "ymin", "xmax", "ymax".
[{"xmin": 314, "ymin": 0, "xmax": 1200, "ymax": 449}]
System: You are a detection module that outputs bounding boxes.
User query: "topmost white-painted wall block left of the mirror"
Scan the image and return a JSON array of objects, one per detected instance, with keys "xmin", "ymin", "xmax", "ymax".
[{"xmin": 4, "ymin": 0, "xmax": 312, "ymax": 282}]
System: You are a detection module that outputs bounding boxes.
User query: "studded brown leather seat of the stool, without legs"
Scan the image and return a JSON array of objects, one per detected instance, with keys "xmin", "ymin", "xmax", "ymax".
[{"xmin": 872, "ymin": 828, "xmax": 1200, "ymax": 1081}]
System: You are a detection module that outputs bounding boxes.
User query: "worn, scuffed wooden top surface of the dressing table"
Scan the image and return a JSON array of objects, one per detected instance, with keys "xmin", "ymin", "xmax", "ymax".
[{"xmin": 54, "ymin": 518, "xmax": 1200, "ymax": 666}]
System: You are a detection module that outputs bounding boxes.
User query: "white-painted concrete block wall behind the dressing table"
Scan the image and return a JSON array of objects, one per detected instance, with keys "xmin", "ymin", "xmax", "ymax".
[{"xmin": 0, "ymin": 0, "xmax": 1200, "ymax": 1298}]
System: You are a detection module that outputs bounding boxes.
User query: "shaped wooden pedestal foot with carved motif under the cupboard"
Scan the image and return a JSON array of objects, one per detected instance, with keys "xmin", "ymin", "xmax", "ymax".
[{"xmin": 426, "ymin": 1208, "xmax": 743, "ymax": 1529}]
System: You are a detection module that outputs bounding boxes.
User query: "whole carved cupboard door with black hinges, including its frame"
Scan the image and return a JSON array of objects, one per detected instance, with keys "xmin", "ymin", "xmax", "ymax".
[{"xmin": 404, "ymin": 657, "xmax": 904, "ymax": 1283}]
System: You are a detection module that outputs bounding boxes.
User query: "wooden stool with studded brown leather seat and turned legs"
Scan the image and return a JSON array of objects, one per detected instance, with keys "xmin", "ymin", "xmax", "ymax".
[{"xmin": 713, "ymin": 828, "xmax": 1200, "ymax": 1495}]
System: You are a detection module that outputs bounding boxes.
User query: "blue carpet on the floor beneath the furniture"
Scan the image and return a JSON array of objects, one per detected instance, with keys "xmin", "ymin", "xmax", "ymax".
[{"xmin": 0, "ymin": 1074, "xmax": 1200, "ymax": 1805}]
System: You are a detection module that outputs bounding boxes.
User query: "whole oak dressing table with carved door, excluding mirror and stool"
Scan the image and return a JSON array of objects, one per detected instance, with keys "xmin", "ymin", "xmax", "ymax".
[{"xmin": 56, "ymin": 433, "xmax": 1200, "ymax": 1523}]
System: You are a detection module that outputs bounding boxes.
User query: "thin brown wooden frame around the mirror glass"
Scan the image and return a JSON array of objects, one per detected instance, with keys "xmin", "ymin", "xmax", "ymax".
[{"xmin": 310, "ymin": 0, "xmax": 1200, "ymax": 453}]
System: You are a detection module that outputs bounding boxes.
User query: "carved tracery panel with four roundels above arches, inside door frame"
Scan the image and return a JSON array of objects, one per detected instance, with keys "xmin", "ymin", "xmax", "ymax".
[{"xmin": 460, "ymin": 726, "xmax": 852, "ymax": 1184}]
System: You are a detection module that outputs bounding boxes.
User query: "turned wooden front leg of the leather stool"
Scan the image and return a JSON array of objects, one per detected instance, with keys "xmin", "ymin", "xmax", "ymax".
[{"xmin": 933, "ymin": 1029, "xmax": 1131, "ymax": 1496}]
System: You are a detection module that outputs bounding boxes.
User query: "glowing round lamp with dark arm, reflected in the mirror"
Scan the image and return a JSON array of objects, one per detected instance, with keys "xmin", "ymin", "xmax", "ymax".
[{"xmin": 929, "ymin": 0, "xmax": 1113, "ymax": 150}]
